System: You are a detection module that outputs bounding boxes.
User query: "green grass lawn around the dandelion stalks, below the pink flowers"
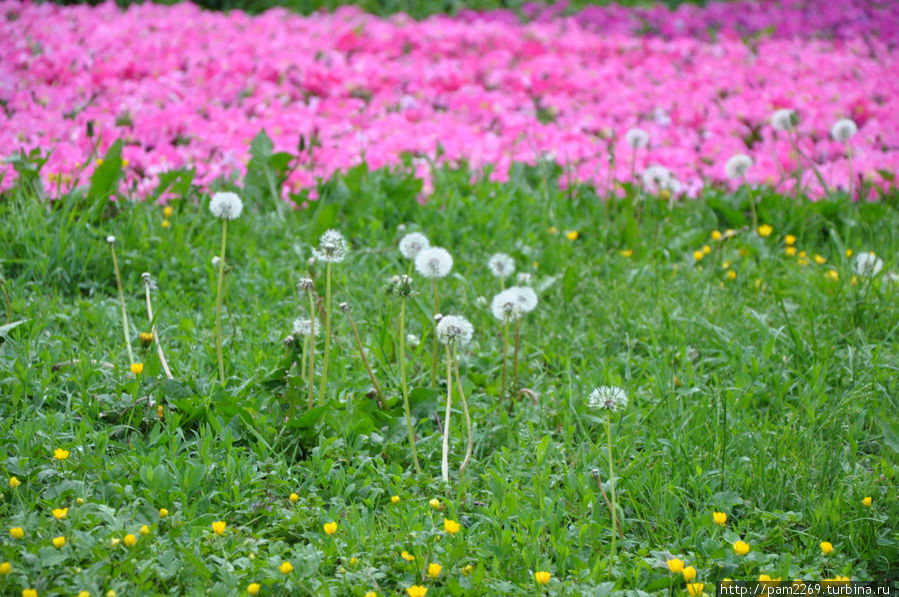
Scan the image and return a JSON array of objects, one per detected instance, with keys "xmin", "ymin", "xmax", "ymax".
[{"xmin": 0, "ymin": 159, "xmax": 899, "ymax": 596}]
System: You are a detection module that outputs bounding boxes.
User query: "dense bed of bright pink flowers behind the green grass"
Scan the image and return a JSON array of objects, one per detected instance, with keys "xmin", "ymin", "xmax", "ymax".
[{"xmin": 0, "ymin": 0, "xmax": 899, "ymax": 201}]
